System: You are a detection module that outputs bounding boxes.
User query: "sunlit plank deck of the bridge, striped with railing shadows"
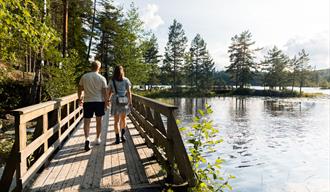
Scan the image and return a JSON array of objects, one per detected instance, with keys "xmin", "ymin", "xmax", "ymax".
[{"xmin": 25, "ymin": 113, "xmax": 164, "ymax": 191}]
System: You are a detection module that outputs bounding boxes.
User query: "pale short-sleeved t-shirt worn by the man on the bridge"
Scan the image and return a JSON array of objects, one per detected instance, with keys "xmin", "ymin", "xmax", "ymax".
[{"xmin": 79, "ymin": 72, "xmax": 107, "ymax": 102}]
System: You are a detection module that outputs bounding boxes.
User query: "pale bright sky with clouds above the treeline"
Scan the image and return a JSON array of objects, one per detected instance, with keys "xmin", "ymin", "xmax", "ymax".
[{"xmin": 114, "ymin": 0, "xmax": 330, "ymax": 70}]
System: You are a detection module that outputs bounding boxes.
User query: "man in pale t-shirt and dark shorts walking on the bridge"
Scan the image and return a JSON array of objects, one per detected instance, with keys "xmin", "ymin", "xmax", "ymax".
[{"xmin": 78, "ymin": 60, "xmax": 108, "ymax": 151}]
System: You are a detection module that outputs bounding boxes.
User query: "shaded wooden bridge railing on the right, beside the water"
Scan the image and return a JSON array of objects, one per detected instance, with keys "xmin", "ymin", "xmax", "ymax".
[{"xmin": 129, "ymin": 94, "xmax": 195, "ymax": 186}]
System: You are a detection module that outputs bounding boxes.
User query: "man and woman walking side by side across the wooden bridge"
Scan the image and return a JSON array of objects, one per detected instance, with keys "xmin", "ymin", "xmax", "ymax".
[{"xmin": 78, "ymin": 61, "xmax": 132, "ymax": 151}]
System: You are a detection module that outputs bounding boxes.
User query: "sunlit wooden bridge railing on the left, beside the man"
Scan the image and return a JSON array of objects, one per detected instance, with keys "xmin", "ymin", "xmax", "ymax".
[{"xmin": 0, "ymin": 94, "xmax": 82, "ymax": 191}]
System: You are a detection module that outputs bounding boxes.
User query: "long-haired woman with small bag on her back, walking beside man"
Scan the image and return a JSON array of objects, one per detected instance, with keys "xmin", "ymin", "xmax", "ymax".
[{"xmin": 108, "ymin": 66, "xmax": 132, "ymax": 144}]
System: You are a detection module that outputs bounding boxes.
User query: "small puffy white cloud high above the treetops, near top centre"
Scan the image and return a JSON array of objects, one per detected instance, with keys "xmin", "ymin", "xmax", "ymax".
[{"xmin": 141, "ymin": 4, "xmax": 164, "ymax": 30}]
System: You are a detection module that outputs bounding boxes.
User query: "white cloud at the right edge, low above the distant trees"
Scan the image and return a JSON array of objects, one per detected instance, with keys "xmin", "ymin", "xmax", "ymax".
[{"xmin": 284, "ymin": 31, "xmax": 330, "ymax": 69}]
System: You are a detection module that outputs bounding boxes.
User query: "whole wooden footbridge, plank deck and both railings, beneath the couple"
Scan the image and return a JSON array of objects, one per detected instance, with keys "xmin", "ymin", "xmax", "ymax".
[{"xmin": 0, "ymin": 94, "xmax": 195, "ymax": 191}]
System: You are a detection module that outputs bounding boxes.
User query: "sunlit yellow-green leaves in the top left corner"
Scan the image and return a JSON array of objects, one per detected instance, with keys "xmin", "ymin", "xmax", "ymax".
[{"xmin": 0, "ymin": 0, "xmax": 59, "ymax": 61}]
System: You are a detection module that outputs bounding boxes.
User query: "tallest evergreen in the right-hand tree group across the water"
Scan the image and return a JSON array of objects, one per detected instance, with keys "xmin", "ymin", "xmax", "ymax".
[{"xmin": 227, "ymin": 31, "xmax": 259, "ymax": 88}]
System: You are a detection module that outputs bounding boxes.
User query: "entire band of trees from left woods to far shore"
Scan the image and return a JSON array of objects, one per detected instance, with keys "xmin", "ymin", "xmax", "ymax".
[{"xmin": 0, "ymin": 0, "xmax": 330, "ymax": 117}]
